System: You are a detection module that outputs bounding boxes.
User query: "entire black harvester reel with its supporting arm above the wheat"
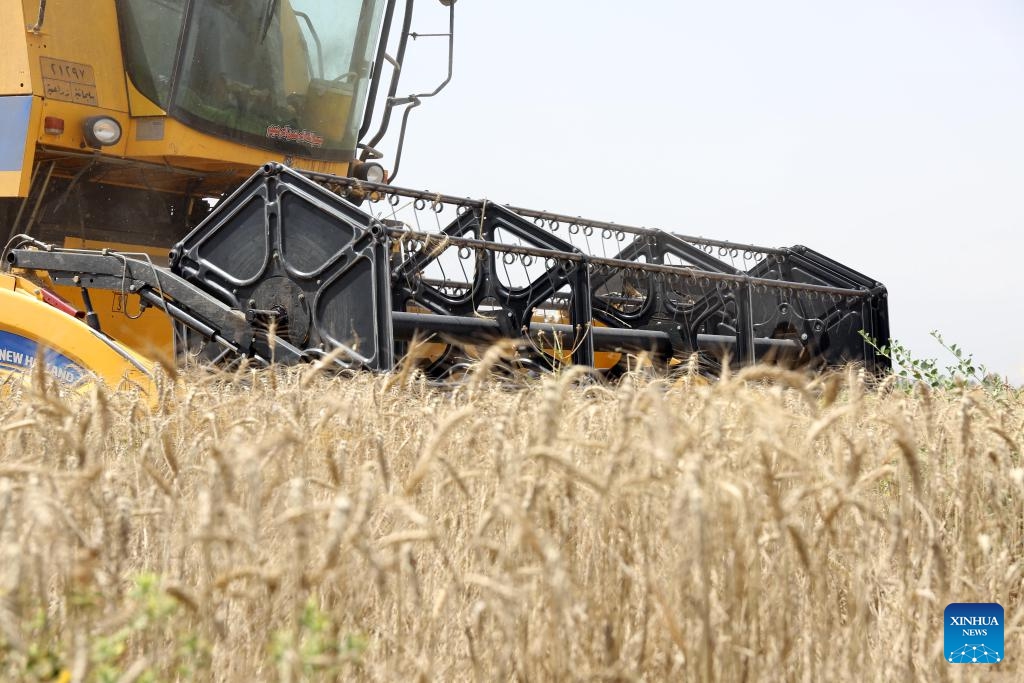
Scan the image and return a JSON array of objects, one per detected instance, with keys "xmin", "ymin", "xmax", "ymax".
[{"xmin": 8, "ymin": 164, "xmax": 890, "ymax": 373}]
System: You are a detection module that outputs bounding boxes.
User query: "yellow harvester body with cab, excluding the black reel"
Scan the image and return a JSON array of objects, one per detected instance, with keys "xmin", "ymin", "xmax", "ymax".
[{"xmin": 0, "ymin": 0, "xmax": 385, "ymax": 389}]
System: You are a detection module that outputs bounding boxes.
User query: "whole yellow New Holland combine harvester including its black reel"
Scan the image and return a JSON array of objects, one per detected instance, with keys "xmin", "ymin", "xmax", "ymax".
[{"xmin": 0, "ymin": 0, "xmax": 889, "ymax": 386}]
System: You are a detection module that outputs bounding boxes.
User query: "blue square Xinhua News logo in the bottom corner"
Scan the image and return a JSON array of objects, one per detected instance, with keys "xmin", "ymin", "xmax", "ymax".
[{"xmin": 943, "ymin": 602, "xmax": 1005, "ymax": 664}]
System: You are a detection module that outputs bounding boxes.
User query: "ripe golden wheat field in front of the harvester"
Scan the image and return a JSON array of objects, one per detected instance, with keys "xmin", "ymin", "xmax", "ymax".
[{"xmin": 0, "ymin": 361, "xmax": 1024, "ymax": 682}]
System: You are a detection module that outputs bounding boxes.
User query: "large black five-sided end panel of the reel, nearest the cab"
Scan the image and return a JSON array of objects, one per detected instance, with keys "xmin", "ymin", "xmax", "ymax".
[{"xmin": 171, "ymin": 165, "xmax": 394, "ymax": 370}]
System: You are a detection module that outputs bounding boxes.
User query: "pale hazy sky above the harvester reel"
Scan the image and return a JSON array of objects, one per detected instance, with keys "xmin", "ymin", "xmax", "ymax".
[{"xmin": 383, "ymin": 0, "xmax": 1024, "ymax": 384}]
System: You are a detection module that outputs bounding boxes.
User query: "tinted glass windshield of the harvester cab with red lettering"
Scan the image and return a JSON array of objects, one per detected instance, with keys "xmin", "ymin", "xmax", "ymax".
[{"xmin": 122, "ymin": 0, "xmax": 385, "ymax": 160}]
